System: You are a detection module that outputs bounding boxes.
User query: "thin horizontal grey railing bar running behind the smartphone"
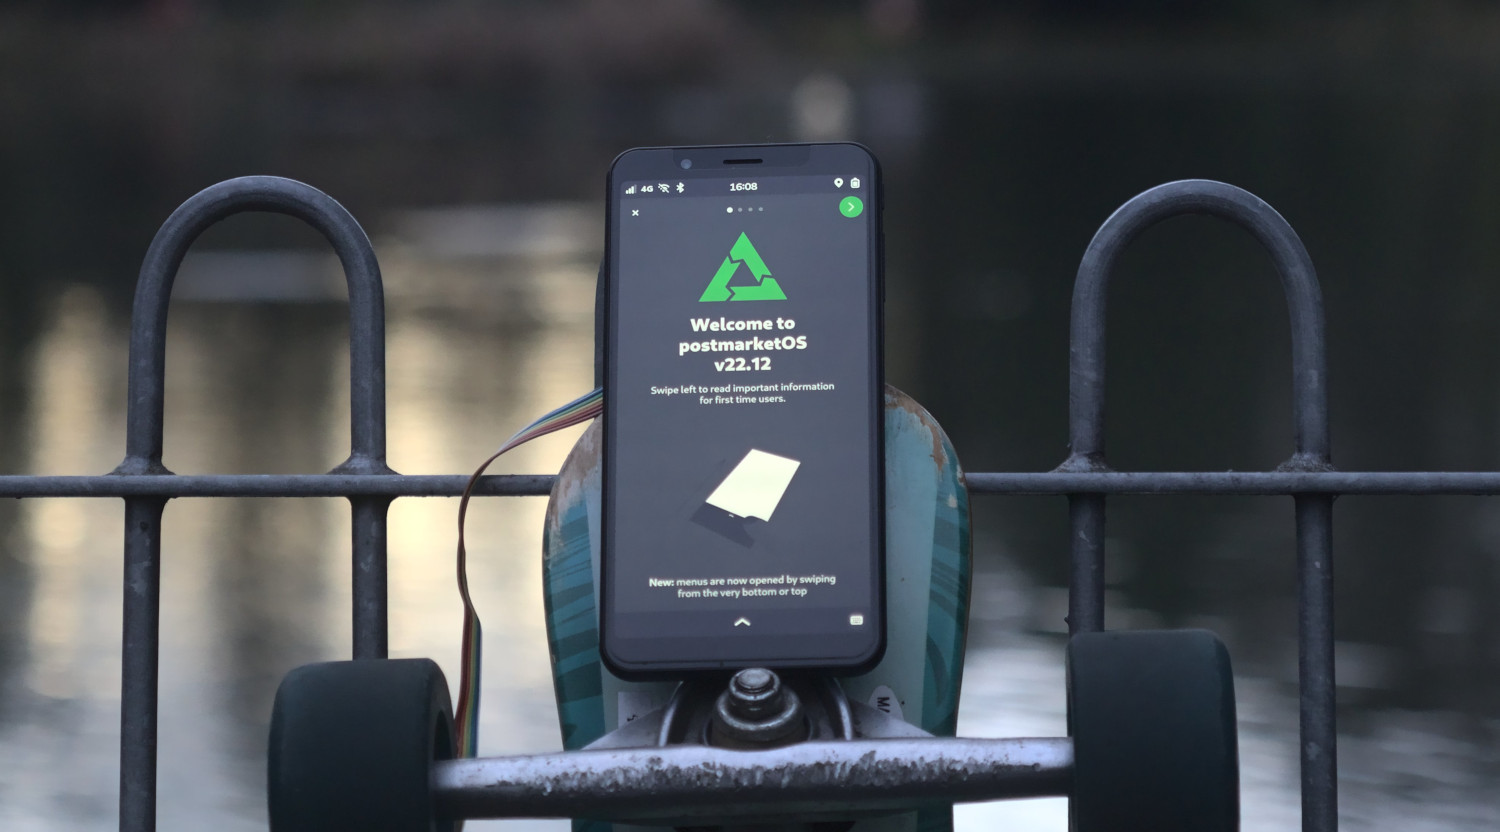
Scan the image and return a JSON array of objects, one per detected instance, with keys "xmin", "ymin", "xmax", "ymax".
[{"xmin": 14, "ymin": 471, "xmax": 1500, "ymax": 498}]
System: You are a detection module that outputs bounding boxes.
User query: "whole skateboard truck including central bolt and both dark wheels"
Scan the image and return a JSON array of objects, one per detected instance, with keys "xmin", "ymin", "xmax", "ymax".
[{"xmin": 269, "ymin": 630, "xmax": 1239, "ymax": 832}]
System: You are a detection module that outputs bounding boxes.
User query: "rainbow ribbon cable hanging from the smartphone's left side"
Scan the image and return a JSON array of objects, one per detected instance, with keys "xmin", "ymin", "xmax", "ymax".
[{"xmin": 453, "ymin": 388, "xmax": 605, "ymax": 757}]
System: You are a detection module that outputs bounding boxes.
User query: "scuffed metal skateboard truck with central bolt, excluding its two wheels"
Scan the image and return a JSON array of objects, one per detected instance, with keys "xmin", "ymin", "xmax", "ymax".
[{"xmin": 432, "ymin": 667, "xmax": 1073, "ymax": 828}]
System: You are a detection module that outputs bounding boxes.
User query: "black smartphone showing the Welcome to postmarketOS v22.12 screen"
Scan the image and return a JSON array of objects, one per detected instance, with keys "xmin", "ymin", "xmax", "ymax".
[{"xmin": 600, "ymin": 144, "xmax": 885, "ymax": 679}]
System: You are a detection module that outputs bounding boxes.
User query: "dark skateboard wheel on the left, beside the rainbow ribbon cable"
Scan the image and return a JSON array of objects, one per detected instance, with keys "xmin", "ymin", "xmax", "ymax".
[{"xmin": 267, "ymin": 658, "xmax": 455, "ymax": 832}]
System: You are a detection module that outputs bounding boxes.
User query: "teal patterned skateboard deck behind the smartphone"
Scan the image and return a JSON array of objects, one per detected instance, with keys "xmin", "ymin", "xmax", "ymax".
[{"xmin": 542, "ymin": 387, "xmax": 972, "ymax": 832}]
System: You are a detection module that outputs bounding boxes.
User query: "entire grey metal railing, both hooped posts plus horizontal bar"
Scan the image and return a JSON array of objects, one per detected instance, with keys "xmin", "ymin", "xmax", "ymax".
[{"xmin": 0, "ymin": 177, "xmax": 1482, "ymax": 832}]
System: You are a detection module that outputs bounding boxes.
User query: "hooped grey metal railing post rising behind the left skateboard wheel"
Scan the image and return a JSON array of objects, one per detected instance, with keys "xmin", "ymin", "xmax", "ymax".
[{"xmin": 113, "ymin": 177, "xmax": 393, "ymax": 832}]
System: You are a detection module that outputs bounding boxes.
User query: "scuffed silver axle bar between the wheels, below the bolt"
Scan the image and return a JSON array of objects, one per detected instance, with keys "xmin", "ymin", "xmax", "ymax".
[{"xmin": 432, "ymin": 738, "xmax": 1073, "ymax": 826}]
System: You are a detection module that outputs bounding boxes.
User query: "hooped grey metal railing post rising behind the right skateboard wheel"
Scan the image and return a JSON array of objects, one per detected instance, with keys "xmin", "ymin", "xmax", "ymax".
[{"xmin": 1058, "ymin": 180, "xmax": 1338, "ymax": 832}]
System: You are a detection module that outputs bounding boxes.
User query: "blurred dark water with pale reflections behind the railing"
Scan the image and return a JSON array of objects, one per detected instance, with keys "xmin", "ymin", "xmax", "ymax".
[{"xmin": 0, "ymin": 0, "xmax": 1500, "ymax": 831}]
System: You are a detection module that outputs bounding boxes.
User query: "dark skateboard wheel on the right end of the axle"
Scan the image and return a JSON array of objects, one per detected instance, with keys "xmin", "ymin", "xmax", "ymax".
[{"xmin": 1068, "ymin": 630, "xmax": 1239, "ymax": 832}]
